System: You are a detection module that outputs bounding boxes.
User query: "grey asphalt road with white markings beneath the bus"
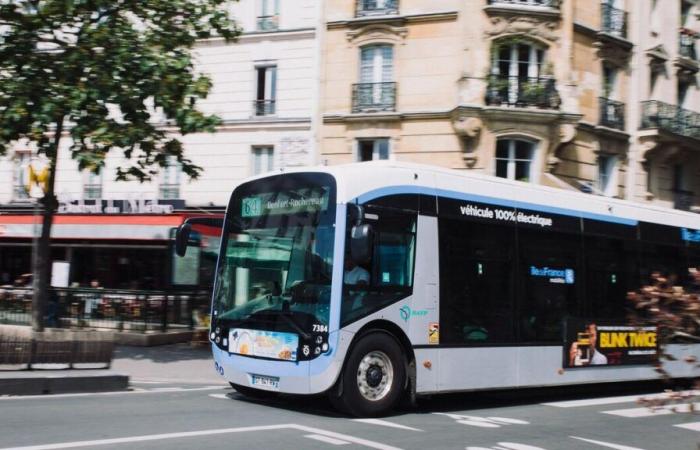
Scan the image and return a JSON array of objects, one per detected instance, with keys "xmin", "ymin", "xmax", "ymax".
[{"xmin": 0, "ymin": 379, "xmax": 700, "ymax": 450}]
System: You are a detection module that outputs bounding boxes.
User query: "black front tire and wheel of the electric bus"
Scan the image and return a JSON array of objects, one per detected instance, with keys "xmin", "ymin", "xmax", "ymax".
[{"xmin": 333, "ymin": 332, "xmax": 406, "ymax": 417}]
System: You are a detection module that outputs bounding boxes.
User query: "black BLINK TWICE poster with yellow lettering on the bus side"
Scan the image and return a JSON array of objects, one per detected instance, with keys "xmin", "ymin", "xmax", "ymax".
[{"xmin": 564, "ymin": 319, "xmax": 658, "ymax": 368}]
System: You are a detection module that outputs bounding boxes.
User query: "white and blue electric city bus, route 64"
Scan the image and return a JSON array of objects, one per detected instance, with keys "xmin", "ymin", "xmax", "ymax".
[{"xmin": 178, "ymin": 161, "xmax": 700, "ymax": 416}]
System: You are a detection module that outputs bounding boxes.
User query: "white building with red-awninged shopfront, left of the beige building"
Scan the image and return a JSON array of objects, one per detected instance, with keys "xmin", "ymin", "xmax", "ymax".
[{"xmin": 0, "ymin": 0, "xmax": 320, "ymax": 289}]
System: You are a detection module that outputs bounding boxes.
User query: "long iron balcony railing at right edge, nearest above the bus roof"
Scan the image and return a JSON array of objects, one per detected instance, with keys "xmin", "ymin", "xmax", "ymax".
[{"xmin": 641, "ymin": 100, "xmax": 700, "ymax": 139}]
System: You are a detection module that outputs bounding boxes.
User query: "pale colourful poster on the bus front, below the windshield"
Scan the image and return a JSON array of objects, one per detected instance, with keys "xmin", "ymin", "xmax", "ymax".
[{"xmin": 228, "ymin": 328, "xmax": 299, "ymax": 361}]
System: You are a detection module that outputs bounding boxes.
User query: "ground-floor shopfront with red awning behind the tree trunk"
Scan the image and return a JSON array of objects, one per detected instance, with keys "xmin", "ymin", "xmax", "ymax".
[{"xmin": 0, "ymin": 212, "xmax": 218, "ymax": 290}]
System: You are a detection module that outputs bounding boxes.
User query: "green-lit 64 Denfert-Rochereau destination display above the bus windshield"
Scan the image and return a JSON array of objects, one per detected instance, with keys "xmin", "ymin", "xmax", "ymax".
[{"xmin": 241, "ymin": 188, "xmax": 329, "ymax": 217}]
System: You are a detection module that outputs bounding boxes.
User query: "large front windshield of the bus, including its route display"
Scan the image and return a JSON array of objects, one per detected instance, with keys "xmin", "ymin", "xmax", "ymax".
[{"xmin": 213, "ymin": 174, "xmax": 335, "ymax": 354}]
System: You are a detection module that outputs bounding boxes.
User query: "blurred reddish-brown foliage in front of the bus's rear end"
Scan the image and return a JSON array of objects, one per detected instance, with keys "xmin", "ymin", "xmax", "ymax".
[{"xmin": 628, "ymin": 268, "xmax": 700, "ymax": 412}]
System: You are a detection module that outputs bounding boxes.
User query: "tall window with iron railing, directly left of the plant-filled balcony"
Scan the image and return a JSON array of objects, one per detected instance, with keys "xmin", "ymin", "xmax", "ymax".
[{"xmin": 353, "ymin": 44, "xmax": 396, "ymax": 112}]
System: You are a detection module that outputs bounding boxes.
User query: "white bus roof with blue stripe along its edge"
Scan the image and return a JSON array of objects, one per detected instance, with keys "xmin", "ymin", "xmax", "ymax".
[{"xmin": 268, "ymin": 161, "xmax": 700, "ymax": 229}]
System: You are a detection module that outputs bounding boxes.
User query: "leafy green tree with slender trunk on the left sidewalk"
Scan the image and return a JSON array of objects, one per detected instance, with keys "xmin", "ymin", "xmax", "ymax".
[{"xmin": 0, "ymin": 0, "xmax": 240, "ymax": 331}]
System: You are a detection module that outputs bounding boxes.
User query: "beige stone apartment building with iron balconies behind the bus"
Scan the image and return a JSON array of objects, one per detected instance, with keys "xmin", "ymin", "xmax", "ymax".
[{"xmin": 319, "ymin": 0, "xmax": 700, "ymax": 209}]
